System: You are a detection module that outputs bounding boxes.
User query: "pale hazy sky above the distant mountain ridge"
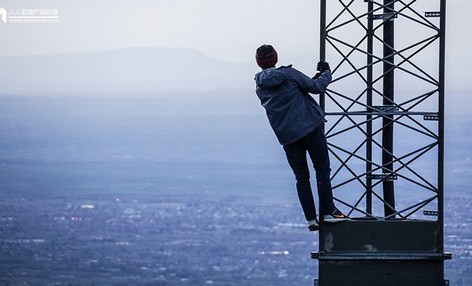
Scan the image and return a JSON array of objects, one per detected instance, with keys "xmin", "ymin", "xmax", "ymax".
[{"xmin": 0, "ymin": 0, "xmax": 472, "ymax": 91}]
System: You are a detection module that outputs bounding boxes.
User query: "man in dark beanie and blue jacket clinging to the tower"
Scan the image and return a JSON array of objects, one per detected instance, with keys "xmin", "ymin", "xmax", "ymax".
[{"xmin": 254, "ymin": 45, "xmax": 349, "ymax": 231}]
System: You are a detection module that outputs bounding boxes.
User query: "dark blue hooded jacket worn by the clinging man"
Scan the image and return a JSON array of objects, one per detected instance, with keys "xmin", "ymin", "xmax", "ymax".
[{"xmin": 254, "ymin": 66, "xmax": 331, "ymax": 145}]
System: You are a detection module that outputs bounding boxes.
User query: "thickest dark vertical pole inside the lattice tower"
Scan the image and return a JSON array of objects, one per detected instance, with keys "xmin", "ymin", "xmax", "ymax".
[{"xmin": 382, "ymin": 0, "xmax": 395, "ymax": 216}]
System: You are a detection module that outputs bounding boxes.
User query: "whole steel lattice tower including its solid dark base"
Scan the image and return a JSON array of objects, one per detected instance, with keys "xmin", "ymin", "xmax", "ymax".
[{"xmin": 312, "ymin": 0, "xmax": 451, "ymax": 286}]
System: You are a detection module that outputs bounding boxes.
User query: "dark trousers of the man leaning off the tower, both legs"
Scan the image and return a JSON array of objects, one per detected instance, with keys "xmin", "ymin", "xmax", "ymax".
[{"xmin": 284, "ymin": 126, "xmax": 335, "ymax": 221}]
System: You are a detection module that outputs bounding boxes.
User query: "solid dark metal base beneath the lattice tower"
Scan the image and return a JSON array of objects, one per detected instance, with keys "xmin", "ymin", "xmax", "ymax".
[{"xmin": 311, "ymin": 219, "xmax": 452, "ymax": 286}]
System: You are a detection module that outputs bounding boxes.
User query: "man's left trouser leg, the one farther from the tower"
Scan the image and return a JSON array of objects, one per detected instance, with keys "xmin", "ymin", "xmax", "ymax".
[{"xmin": 284, "ymin": 140, "xmax": 316, "ymax": 221}]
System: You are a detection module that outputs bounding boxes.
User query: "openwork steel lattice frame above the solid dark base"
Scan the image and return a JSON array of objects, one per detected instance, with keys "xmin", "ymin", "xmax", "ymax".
[{"xmin": 320, "ymin": 0, "xmax": 446, "ymax": 232}]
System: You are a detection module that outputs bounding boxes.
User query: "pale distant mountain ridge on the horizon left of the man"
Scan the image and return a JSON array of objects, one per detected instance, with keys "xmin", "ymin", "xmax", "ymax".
[{"xmin": 0, "ymin": 48, "xmax": 257, "ymax": 94}]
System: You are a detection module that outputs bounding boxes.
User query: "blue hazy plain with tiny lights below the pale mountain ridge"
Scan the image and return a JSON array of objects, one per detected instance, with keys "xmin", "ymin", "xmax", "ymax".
[{"xmin": 0, "ymin": 92, "xmax": 472, "ymax": 285}]
